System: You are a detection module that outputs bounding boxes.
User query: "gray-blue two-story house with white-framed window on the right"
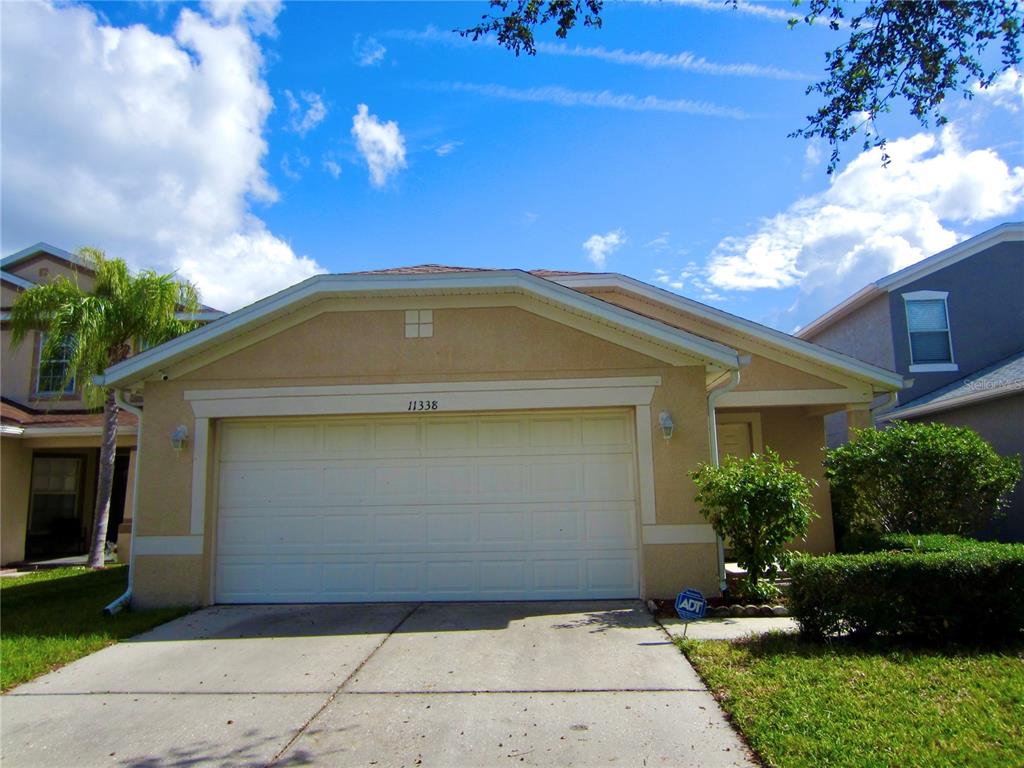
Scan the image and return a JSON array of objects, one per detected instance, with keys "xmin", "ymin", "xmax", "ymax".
[{"xmin": 797, "ymin": 222, "xmax": 1024, "ymax": 541}]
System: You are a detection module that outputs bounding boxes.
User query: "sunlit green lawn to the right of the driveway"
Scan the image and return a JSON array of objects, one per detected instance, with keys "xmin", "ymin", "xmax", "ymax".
[{"xmin": 677, "ymin": 635, "xmax": 1024, "ymax": 768}]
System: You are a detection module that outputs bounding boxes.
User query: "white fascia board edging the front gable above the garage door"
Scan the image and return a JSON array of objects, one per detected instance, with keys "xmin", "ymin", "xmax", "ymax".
[{"xmin": 94, "ymin": 270, "xmax": 739, "ymax": 386}]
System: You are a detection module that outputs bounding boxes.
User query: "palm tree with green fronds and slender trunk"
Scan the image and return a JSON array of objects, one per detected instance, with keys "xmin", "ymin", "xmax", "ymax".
[{"xmin": 10, "ymin": 248, "xmax": 200, "ymax": 568}]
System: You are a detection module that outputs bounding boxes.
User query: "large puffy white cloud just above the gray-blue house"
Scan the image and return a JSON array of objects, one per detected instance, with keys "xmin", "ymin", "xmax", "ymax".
[{"xmin": 707, "ymin": 125, "xmax": 1024, "ymax": 318}]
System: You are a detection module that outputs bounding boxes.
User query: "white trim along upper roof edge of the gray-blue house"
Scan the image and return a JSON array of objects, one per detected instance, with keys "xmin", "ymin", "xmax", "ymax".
[{"xmin": 795, "ymin": 221, "xmax": 1024, "ymax": 339}]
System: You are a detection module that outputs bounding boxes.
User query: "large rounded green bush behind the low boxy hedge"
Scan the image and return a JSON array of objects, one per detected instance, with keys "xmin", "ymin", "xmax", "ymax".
[{"xmin": 824, "ymin": 422, "xmax": 1021, "ymax": 534}]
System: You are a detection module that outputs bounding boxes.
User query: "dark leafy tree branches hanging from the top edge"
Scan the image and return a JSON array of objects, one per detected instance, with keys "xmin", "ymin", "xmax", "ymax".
[{"xmin": 457, "ymin": 0, "xmax": 1022, "ymax": 174}]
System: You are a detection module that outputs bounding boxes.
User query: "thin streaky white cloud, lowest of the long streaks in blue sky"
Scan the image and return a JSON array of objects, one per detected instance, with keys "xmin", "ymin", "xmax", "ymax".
[{"xmin": 444, "ymin": 83, "xmax": 751, "ymax": 120}]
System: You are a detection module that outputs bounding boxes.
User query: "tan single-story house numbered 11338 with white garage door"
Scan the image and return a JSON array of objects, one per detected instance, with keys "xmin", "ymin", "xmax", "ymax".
[{"xmin": 92, "ymin": 265, "xmax": 902, "ymax": 606}]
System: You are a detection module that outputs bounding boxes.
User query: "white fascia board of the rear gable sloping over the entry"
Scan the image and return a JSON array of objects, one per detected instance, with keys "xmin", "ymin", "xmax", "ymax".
[{"xmin": 557, "ymin": 273, "xmax": 903, "ymax": 391}]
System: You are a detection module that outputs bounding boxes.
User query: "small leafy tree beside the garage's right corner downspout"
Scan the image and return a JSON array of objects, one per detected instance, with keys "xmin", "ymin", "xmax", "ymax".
[{"xmin": 691, "ymin": 450, "xmax": 816, "ymax": 598}]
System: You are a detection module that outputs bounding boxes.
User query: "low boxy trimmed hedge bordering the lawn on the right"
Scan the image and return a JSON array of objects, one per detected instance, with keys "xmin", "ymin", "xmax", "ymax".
[{"xmin": 790, "ymin": 540, "xmax": 1024, "ymax": 643}]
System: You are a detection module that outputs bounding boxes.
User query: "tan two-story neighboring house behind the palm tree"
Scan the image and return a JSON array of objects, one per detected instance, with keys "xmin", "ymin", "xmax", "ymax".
[{"xmin": 0, "ymin": 243, "xmax": 222, "ymax": 565}]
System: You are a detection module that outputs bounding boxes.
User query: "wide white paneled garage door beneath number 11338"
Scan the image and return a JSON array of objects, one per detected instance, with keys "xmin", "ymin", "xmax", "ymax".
[{"xmin": 215, "ymin": 411, "xmax": 639, "ymax": 603}]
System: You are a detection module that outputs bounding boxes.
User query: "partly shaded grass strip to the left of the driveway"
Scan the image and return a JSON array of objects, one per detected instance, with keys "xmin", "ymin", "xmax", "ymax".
[{"xmin": 0, "ymin": 565, "xmax": 188, "ymax": 690}]
